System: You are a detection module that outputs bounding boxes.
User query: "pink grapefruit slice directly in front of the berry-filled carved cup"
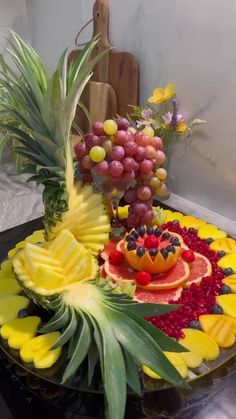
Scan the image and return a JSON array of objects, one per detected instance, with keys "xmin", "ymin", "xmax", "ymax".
[{"xmin": 137, "ymin": 258, "xmax": 190, "ymax": 291}]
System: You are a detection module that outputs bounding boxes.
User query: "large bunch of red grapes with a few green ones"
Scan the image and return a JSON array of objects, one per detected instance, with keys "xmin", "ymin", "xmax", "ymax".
[{"xmin": 75, "ymin": 117, "xmax": 168, "ymax": 228}]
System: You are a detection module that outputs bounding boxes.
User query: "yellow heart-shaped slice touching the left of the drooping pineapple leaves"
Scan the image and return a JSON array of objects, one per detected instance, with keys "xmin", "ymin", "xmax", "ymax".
[{"xmin": 20, "ymin": 332, "xmax": 62, "ymax": 369}]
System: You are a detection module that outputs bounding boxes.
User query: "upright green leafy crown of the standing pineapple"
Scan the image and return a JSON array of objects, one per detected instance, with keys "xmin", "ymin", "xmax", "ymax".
[{"xmin": 0, "ymin": 32, "xmax": 106, "ymax": 175}]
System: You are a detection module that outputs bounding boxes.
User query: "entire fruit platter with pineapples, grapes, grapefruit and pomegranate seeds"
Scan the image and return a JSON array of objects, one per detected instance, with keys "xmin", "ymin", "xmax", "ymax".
[{"xmin": 0, "ymin": 33, "xmax": 236, "ymax": 419}]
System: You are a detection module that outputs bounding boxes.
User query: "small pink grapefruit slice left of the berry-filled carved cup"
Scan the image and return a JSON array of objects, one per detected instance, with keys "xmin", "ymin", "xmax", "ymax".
[{"xmin": 104, "ymin": 260, "xmax": 136, "ymax": 283}]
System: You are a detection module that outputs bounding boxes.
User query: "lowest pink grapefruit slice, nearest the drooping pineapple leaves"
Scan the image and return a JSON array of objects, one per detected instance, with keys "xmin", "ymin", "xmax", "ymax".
[{"xmin": 134, "ymin": 287, "xmax": 183, "ymax": 304}]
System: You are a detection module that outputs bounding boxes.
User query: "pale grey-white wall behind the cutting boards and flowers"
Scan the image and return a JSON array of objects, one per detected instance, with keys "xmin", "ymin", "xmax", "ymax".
[{"xmin": 1, "ymin": 0, "xmax": 236, "ymax": 219}]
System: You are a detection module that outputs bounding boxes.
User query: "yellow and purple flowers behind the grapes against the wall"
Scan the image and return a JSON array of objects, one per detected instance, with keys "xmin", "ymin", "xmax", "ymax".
[{"xmin": 131, "ymin": 83, "xmax": 206, "ymax": 153}]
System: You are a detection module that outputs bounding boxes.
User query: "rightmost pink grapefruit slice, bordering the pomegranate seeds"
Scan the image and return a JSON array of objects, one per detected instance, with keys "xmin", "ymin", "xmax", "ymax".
[{"xmin": 184, "ymin": 252, "xmax": 212, "ymax": 288}]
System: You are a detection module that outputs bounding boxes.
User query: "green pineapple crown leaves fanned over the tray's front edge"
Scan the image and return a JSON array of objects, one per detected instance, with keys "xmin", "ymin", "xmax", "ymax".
[{"xmin": 40, "ymin": 281, "xmax": 188, "ymax": 419}]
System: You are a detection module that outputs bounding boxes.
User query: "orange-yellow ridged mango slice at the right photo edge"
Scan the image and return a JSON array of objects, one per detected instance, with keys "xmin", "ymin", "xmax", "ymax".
[{"xmin": 199, "ymin": 314, "xmax": 236, "ymax": 348}]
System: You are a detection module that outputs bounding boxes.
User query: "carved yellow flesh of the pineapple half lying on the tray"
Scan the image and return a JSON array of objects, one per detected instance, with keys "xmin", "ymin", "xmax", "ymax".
[{"xmin": 13, "ymin": 230, "xmax": 99, "ymax": 295}]
